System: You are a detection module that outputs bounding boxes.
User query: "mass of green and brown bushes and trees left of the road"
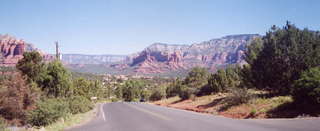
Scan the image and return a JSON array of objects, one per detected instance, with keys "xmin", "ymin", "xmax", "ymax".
[{"xmin": 0, "ymin": 52, "xmax": 105, "ymax": 128}]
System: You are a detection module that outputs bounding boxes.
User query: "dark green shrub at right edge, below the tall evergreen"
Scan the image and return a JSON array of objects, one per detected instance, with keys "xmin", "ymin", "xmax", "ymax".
[{"xmin": 293, "ymin": 67, "xmax": 320, "ymax": 104}]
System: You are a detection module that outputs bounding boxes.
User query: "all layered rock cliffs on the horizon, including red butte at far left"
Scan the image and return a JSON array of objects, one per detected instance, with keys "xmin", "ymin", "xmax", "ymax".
[{"xmin": 0, "ymin": 34, "xmax": 260, "ymax": 74}]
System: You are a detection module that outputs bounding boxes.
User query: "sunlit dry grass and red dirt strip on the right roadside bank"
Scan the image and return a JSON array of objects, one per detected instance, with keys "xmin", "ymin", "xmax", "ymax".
[{"xmin": 154, "ymin": 90, "xmax": 293, "ymax": 119}]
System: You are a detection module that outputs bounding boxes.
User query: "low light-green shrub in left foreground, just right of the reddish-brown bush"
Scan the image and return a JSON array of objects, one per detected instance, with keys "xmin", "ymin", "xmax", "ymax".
[{"xmin": 27, "ymin": 99, "xmax": 70, "ymax": 126}]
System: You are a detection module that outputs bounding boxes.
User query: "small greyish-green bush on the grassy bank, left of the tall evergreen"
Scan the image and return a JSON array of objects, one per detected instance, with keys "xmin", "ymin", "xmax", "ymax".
[{"xmin": 226, "ymin": 88, "xmax": 253, "ymax": 105}]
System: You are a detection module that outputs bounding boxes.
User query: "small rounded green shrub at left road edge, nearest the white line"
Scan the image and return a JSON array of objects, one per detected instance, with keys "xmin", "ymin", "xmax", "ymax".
[{"xmin": 69, "ymin": 96, "xmax": 93, "ymax": 114}]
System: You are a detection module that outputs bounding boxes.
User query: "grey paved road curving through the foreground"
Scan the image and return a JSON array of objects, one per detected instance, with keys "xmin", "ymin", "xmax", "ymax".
[{"xmin": 69, "ymin": 102, "xmax": 320, "ymax": 131}]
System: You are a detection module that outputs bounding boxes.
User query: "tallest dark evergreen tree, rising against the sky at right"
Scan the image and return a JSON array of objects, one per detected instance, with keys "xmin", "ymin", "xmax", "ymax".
[{"xmin": 244, "ymin": 22, "xmax": 320, "ymax": 94}]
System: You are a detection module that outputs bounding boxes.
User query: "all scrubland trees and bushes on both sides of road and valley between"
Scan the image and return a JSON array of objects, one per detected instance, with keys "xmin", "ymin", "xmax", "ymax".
[{"xmin": 0, "ymin": 22, "xmax": 320, "ymax": 129}]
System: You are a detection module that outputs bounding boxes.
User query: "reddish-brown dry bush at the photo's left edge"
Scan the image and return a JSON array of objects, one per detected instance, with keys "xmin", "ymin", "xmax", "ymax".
[{"xmin": 0, "ymin": 73, "xmax": 38, "ymax": 124}]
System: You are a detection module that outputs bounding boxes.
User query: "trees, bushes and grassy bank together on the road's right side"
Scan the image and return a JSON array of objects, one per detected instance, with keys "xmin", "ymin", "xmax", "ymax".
[{"xmin": 155, "ymin": 22, "xmax": 320, "ymax": 118}]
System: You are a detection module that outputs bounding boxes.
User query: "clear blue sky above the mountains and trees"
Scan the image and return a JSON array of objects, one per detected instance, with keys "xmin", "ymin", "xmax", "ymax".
[{"xmin": 0, "ymin": 0, "xmax": 320, "ymax": 54}]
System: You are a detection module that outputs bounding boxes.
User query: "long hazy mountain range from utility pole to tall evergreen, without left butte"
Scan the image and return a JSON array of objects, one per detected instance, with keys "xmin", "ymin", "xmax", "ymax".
[{"xmin": 62, "ymin": 34, "xmax": 261, "ymax": 75}]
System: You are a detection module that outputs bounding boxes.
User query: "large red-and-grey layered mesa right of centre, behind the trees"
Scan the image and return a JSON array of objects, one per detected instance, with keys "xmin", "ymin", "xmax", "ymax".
[{"xmin": 126, "ymin": 34, "xmax": 259, "ymax": 74}]
